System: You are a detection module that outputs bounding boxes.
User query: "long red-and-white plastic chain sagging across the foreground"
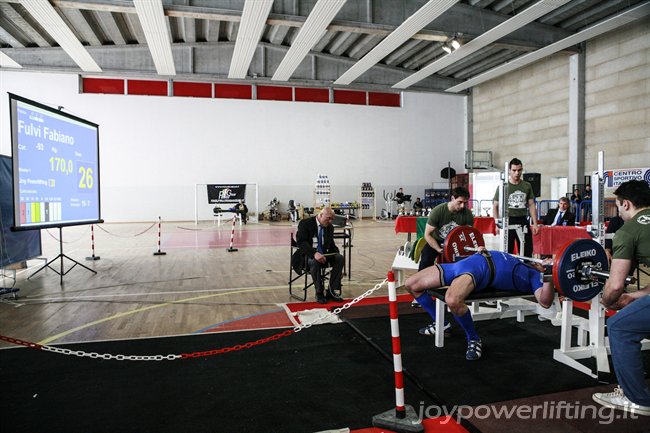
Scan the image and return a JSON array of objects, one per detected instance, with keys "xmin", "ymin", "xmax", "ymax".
[{"xmin": 0, "ymin": 279, "xmax": 388, "ymax": 361}]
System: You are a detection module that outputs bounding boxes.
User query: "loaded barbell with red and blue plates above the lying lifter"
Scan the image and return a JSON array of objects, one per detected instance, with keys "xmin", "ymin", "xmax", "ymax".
[{"xmin": 443, "ymin": 226, "xmax": 636, "ymax": 302}]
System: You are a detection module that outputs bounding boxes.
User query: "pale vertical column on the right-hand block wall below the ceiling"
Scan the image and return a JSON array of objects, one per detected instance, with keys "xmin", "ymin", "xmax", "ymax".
[{"xmin": 568, "ymin": 47, "xmax": 585, "ymax": 189}]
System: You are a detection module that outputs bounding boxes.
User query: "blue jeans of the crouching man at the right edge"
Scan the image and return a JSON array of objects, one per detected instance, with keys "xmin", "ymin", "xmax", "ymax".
[{"xmin": 607, "ymin": 296, "xmax": 650, "ymax": 406}]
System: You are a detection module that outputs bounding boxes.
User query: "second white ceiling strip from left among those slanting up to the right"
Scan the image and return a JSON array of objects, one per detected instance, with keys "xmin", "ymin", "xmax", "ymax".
[{"xmin": 271, "ymin": 0, "xmax": 347, "ymax": 81}]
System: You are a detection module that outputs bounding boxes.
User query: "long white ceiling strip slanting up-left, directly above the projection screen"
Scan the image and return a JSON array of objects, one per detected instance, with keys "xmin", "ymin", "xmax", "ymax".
[{"xmin": 20, "ymin": 0, "xmax": 102, "ymax": 72}]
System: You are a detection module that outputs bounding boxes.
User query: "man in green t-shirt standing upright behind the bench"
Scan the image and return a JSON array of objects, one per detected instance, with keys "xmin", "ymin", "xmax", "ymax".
[{"xmin": 493, "ymin": 158, "xmax": 539, "ymax": 257}]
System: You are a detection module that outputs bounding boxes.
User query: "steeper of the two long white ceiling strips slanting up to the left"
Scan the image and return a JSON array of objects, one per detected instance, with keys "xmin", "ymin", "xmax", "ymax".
[{"xmin": 133, "ymin": 0, "xmax": 176, "ymax": 75}]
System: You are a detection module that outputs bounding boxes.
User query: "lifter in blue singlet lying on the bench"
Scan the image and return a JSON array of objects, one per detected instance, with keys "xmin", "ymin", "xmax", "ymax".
[{"xmin": 406, "ymin": 247, "xmax": 555, "ymax": 361}]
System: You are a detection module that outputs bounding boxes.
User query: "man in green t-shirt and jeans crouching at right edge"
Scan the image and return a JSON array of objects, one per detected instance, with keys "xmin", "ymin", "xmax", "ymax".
[{"xmin": 593, "ymin": 180, "xmax": 650, "ymax": 416}]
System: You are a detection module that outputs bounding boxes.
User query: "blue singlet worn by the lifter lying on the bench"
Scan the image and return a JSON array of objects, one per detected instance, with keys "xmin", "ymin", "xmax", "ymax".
[{"xmin": 436, "ymin": 251, "xmax": 544, "ymax": 294}]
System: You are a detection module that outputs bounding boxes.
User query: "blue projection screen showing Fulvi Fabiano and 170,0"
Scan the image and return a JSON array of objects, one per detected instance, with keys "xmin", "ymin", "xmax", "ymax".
[{"xmin": 9, "ymin": 94, "xmax": 101, "ymax": 229}]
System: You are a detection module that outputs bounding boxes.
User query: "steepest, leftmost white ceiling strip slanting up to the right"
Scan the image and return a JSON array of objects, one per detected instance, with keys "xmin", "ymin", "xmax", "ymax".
[{"xmin": 228, "ymin": 0, "xmax": 273, "ymax": 79}]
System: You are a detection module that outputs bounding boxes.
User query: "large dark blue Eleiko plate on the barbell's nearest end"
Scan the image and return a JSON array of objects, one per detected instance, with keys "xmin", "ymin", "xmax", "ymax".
[{"xmin": 553, "ymin": 239, "xmax": 609, "ymax": 302}]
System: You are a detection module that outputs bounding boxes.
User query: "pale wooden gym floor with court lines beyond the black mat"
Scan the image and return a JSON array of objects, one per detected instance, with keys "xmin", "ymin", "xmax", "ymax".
[{"xmin": 0, "ymin": 220, "xmax": 646, "ymax": 432}]
